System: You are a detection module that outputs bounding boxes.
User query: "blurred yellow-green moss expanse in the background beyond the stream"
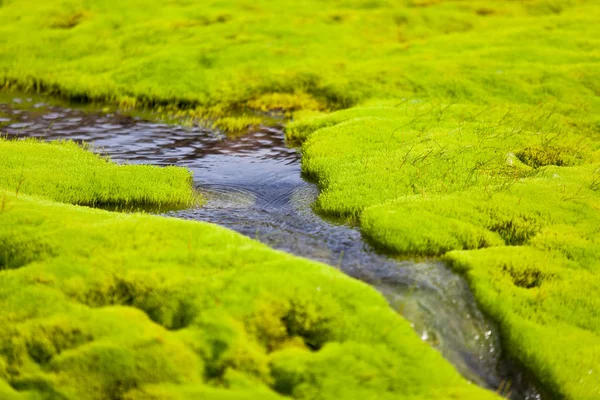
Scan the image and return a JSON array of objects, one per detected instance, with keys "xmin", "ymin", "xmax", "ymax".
[{"xmin": 0, "ymin": 0, "xmax": 600, "ymax": 110}]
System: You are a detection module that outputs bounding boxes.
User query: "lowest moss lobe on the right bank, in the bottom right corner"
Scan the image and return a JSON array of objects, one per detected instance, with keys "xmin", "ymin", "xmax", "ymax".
[{"xmin": 447, "ymin": 248, "xmax": 600, "ymax": 399}]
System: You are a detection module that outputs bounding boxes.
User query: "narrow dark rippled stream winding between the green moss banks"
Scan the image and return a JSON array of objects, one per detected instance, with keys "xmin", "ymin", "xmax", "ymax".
[{"xmin": 0, "ymin": 99, "xmax": 542, "ymax": 400}]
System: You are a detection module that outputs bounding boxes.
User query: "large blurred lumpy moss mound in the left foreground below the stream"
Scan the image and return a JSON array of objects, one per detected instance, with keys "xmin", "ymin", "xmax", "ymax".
[{"xmin": 0, "ymin": 192, "xmax": 496, "ymax": 399}]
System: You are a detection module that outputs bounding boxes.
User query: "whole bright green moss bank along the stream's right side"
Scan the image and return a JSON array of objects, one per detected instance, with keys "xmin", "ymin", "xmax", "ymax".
[{"xmin": 288, "ymin": 102, "xmax": 600, "ymax": 400}]
